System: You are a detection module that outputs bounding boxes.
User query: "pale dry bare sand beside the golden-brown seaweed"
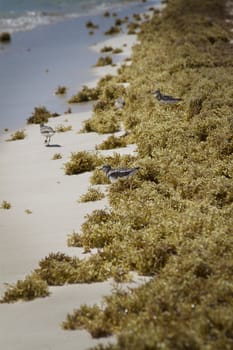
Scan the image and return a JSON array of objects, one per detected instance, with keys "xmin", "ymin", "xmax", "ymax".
[{"xmin": 0, "ymin": 31, "xmax": 144, "ymax": 350}]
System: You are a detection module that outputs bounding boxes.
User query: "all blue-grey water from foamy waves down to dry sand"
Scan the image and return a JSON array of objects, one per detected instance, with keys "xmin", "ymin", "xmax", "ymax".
[{"xmin": 0, "ymin": 0, "xmax": 160, "ymax": 133}]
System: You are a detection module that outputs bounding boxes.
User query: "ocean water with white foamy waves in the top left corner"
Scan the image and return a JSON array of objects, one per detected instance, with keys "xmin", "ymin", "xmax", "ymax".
[{"xmin": 0, "ymin": 0, "xmax": 149, "ymax": 33}]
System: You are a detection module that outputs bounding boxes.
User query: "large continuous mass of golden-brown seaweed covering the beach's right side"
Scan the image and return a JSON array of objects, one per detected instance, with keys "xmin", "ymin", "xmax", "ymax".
[{"xmin": 1, "ymin": 0, "xmax": 233, "ymax": 350}]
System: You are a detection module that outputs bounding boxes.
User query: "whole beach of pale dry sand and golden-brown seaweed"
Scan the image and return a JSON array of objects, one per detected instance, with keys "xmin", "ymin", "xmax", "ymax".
[{"xmin": 0, "ymin": 0, "xmax": 233, "ymax": 350}]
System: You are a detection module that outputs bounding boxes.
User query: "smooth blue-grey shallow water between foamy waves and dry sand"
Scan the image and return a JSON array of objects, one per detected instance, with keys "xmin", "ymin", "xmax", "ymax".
[{"xmin": 0, "ymin": 0, "xmax": 160, "ymax": 132}]
